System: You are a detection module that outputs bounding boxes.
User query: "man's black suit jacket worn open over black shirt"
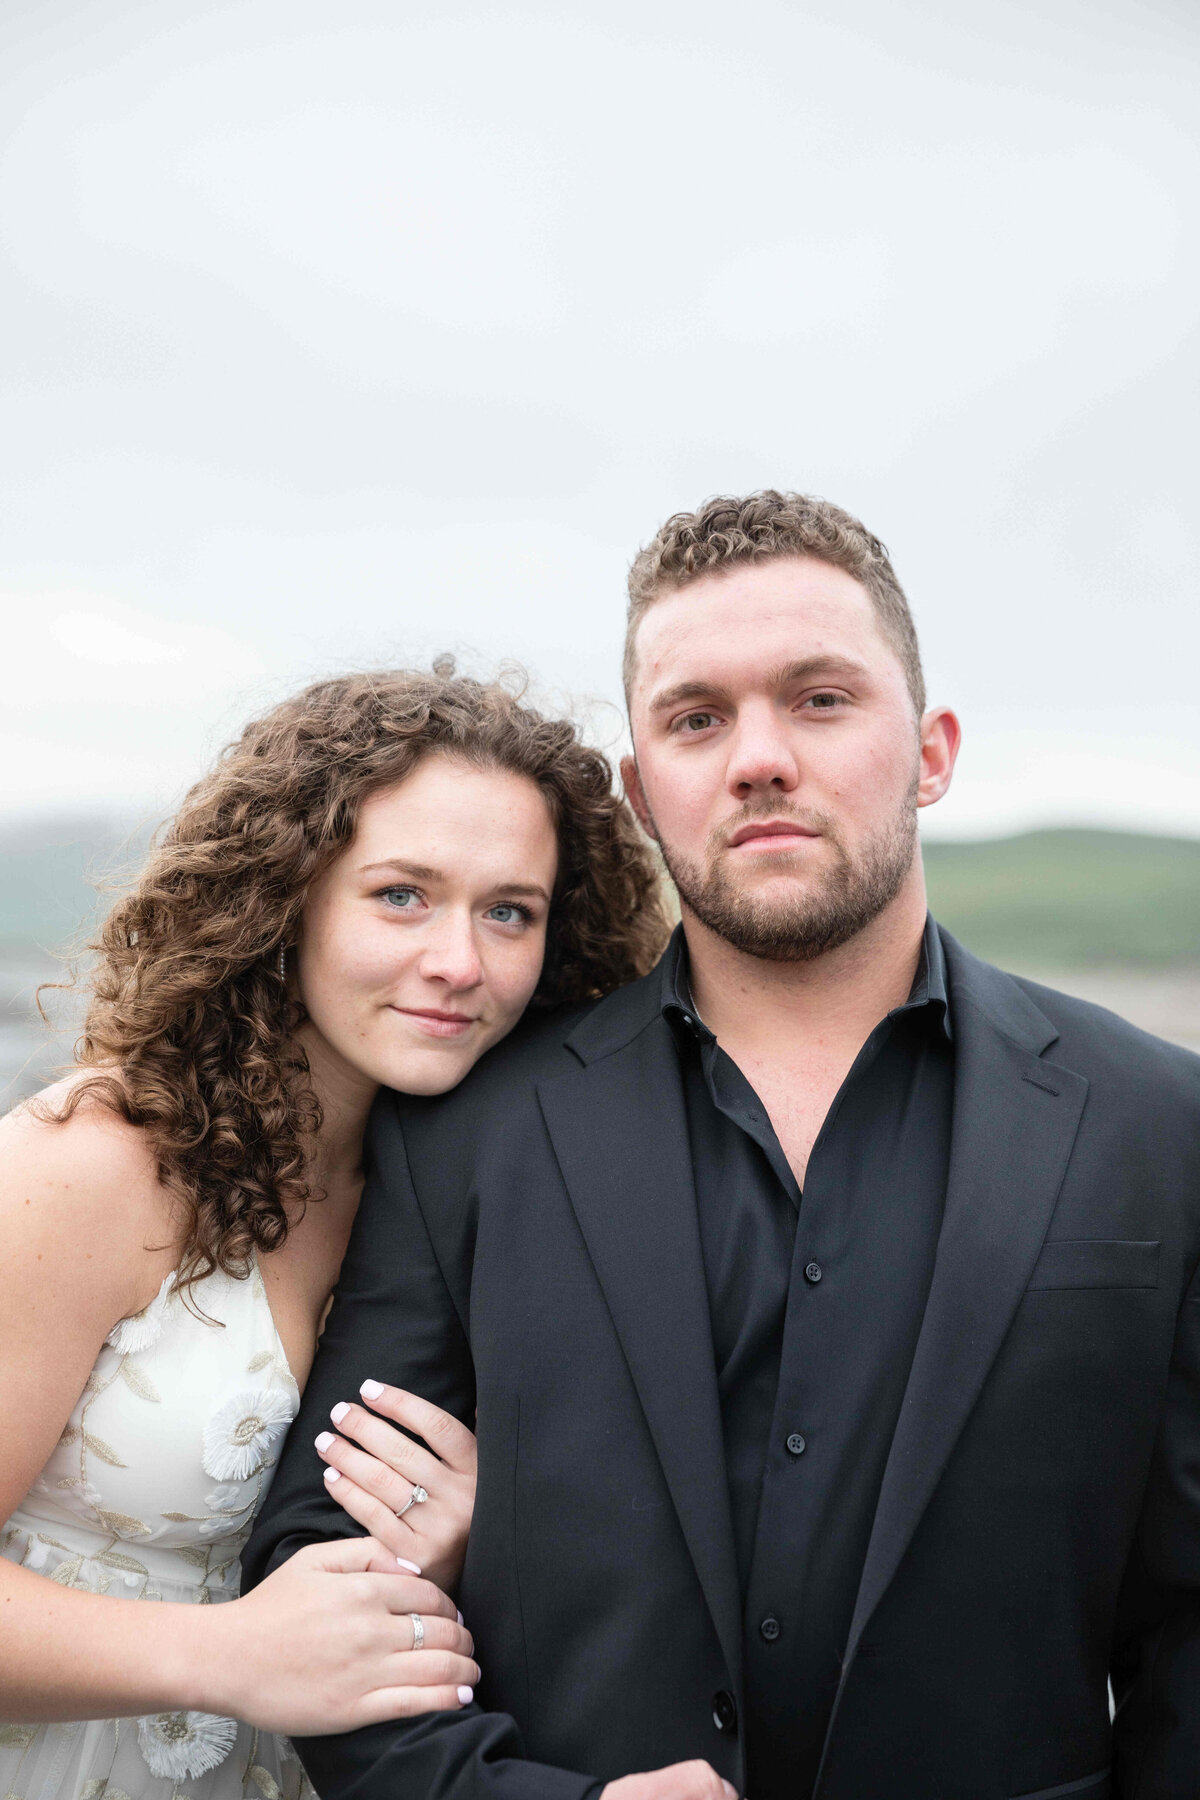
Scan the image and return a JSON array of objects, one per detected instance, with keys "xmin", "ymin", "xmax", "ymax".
[{"xmin": 246, "ymin": 934, "xmax": 1200, "ymax": 1800}]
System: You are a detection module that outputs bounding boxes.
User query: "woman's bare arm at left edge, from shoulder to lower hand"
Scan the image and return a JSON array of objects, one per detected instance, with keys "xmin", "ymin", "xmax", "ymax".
[{"xmin": 0, "ymin": 1103, "xmax": 477, "ymax": 1732}]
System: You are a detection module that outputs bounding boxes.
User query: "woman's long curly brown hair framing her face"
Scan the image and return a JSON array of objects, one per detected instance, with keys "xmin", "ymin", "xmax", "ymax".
[{"xmin": 54, "ymin": 659, "xmax": 669, "ymax": 1283}]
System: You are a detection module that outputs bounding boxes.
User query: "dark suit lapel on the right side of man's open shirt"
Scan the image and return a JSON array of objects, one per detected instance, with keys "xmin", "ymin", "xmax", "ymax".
[{"xmin": 829, "ymin": 940, "xmax": 1088, "ymax": 1764}]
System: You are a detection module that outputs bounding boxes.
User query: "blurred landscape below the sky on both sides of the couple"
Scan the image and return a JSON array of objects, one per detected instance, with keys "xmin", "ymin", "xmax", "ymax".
[{"xmin": 0, "ymin": 814, "xmax": 1200, "ymax": 1112}]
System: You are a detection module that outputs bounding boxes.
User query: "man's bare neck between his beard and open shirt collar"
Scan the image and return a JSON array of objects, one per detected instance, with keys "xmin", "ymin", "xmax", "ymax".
[{"xmin": 682, "ymin": 866, "xmax": 927, "ymax": 1062}]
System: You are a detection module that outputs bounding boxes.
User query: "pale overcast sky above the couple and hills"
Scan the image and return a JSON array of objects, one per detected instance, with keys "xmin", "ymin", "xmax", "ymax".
[{"xmin": 0, "ymin": 0, "xmax": 1200, "ymax": 835}]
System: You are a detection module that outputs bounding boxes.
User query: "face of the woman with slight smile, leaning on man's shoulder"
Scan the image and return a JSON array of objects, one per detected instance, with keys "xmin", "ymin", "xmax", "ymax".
[{"xmin": 297, "ymin": 754, "xmax": 558, "ymax": 1094}]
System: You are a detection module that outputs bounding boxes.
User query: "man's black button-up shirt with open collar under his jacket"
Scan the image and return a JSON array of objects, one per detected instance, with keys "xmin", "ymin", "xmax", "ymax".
[{"xmin": 662, "ymin": 920, "xmax": 954, "ymax": 1800}]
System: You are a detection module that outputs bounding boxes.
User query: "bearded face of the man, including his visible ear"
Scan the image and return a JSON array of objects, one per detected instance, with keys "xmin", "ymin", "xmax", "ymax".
[{"xmin": 624, "ymin": 556, "xmax": 957, "ymax": 961}]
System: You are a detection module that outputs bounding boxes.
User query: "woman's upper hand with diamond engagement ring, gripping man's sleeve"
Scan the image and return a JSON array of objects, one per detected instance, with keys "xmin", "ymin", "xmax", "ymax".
[{"xmin": 317, "ymin": 1381, "xmax": 475, "ymax": 1591}]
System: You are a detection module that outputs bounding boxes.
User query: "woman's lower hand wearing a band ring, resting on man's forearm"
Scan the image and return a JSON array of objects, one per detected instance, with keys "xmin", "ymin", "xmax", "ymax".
[{"xmin": 199, "ymin": 1537, "xmax": 479, "ymax": 1737}]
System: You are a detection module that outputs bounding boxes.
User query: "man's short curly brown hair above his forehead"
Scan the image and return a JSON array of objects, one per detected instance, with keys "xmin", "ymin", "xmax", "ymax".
[{"xmin": 624, "ymin": 488, "xmax": 925, "ymax": 718}]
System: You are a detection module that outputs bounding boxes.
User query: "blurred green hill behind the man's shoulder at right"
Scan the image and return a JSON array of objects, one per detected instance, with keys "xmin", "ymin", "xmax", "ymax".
[{"xmin": 925, "ymin": 830, "xmax": 1200, "ymax": 968}]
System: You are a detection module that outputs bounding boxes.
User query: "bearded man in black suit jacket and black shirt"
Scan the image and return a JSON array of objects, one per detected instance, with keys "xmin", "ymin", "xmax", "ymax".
[{"xmin": 248, "ymin": 493, "xmax": 1200, "ymax": 1800}]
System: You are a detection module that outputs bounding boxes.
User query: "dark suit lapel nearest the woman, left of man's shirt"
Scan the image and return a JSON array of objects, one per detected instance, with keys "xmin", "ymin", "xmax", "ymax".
[{"xmin": 538, "ymin": 1019, "xmax": 741, "ymax": 1690}]
